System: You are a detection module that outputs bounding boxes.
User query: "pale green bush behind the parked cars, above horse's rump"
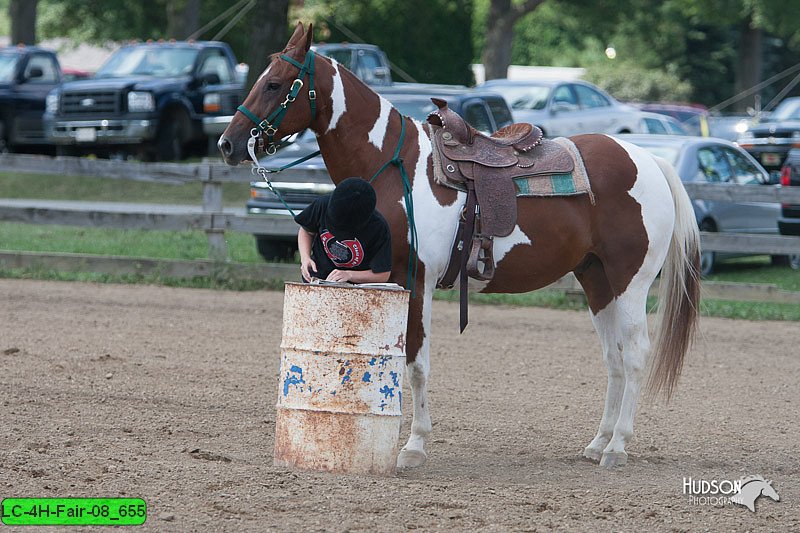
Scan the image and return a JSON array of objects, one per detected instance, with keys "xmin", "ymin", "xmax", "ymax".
[{"xmin": 583, "ymin": 61, "xmax": 692, "ymax": 102}]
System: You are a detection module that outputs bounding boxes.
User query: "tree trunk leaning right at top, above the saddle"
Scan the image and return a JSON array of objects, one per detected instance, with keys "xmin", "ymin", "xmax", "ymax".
[{"xmin": 481, "ymin": 0, "xmax": 544, "ymax": 80}]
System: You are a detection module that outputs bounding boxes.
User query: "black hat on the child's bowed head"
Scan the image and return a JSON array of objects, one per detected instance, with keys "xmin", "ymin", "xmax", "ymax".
[{"xmin": 326, "ymin": 178, "xmax": 377, "ymax": 235}]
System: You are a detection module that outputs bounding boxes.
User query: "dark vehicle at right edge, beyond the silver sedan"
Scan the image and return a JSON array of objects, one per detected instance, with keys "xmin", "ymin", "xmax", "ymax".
[{"xmin": 737, "ymin": 97, "xmax": 800, "ymax": 177}]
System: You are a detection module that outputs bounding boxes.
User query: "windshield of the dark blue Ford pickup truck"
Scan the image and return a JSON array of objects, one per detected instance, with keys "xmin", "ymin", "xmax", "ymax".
[{"xmin": 95, "ymin": 47, "xmax": 198, "ymax": 78}]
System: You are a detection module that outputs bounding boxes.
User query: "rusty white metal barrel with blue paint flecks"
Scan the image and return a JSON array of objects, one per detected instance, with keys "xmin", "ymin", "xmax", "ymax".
[{"xmin": 275, "ymin": 283, "xmax": 409, "ymax": 475}]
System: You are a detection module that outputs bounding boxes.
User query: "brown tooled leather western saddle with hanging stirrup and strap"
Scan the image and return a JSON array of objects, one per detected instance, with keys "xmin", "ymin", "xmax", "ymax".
[{"xmin": 427, "ymin": 98, "xmax": 574, "ymax": 332}]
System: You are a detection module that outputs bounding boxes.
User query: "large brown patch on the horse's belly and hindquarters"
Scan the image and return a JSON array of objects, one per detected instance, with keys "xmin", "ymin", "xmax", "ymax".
[{"xmin": 481, "ymin": 135, "xmax": 649, "ymax": 313}]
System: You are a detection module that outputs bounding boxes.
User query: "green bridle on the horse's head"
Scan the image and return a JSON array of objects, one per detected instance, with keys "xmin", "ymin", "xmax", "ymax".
[{"xmin": 236, "ymin": 50, "xmax": 317, "ymax": 158}]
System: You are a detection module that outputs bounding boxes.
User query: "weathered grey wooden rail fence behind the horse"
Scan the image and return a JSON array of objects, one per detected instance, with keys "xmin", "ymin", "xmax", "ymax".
[{"xmin": 0, "ymin": 154, "xmax": 800, "ymax": 304}]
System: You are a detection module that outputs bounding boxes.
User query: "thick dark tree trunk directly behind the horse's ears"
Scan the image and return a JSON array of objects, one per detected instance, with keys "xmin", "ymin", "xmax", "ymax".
[{"xmin": 244, "ymin": 0, "xmax": 289, "ymax": 90}]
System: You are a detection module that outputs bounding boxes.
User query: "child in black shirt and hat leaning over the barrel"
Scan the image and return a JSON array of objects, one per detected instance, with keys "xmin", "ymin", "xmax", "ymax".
[{"xmin": 294, "ymin": 178, "xmax": 392, "ymax": 283}]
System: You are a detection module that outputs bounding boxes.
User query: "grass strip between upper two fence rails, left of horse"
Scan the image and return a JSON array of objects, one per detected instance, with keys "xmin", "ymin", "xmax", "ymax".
[{"xmin": 0, "ymin": 172, "xmax": 250, "ymax": 207}]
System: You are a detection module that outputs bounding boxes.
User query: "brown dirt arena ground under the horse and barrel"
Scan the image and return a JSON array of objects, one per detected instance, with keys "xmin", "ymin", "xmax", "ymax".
[{"xmin": 0, "ymin": 280, "xmax": 800, "ymax": 532}]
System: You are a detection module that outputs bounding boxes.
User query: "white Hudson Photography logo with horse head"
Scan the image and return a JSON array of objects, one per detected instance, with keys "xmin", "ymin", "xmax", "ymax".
[{"xmin": 683, "ymin": 476, "xmax": 780, "ymax": 512}]
